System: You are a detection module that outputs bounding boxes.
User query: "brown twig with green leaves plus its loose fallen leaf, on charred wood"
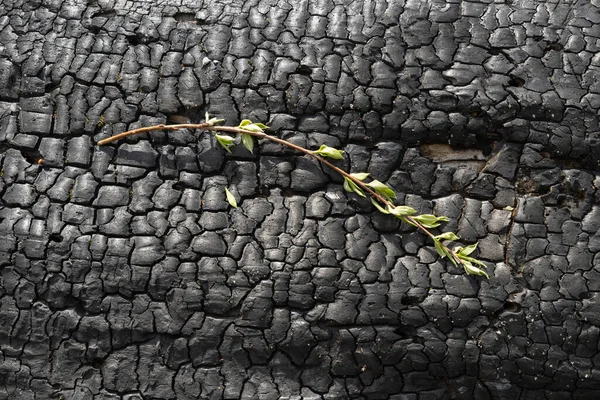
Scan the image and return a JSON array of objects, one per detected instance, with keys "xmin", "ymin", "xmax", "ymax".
[{"xmin": 98, "ymin": 113, "xmax": 489, "ymax": 279}]
